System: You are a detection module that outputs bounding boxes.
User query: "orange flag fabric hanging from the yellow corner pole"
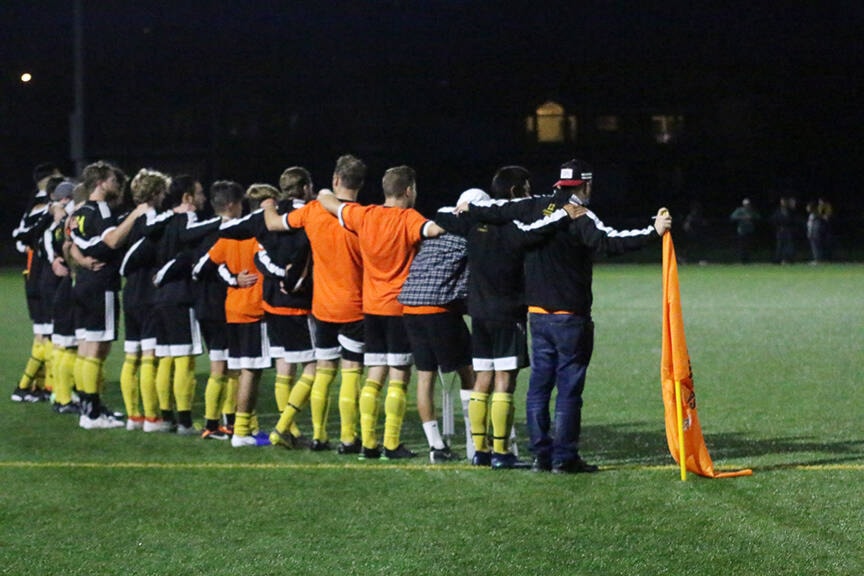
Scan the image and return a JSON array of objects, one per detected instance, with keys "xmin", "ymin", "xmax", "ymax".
[{"xmin": 660, "ymin": 232, "xmax": 753, "ymax": 478}]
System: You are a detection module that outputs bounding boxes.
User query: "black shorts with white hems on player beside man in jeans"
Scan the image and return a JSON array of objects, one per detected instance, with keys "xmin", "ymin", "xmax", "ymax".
[{"xmin": 471, "ymin": 319, "xmax": 530, "ymax": 372}]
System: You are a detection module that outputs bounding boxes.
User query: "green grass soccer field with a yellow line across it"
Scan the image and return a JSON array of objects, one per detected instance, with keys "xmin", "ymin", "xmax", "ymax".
[{"xmin": 0, "ymin": 263, "xmax": 864, "ymax": 576}]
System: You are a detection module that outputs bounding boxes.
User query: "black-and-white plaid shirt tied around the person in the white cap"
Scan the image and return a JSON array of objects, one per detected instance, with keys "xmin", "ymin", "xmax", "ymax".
[{"xmin": 399, "ymin": 234, "xmax": 468, "ymax": 306}]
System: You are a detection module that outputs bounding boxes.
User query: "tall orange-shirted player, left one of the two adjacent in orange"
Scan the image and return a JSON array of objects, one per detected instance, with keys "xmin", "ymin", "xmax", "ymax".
[{"xmin": 256, "ymin": 154, "xmax": 366, "ymax": 454}]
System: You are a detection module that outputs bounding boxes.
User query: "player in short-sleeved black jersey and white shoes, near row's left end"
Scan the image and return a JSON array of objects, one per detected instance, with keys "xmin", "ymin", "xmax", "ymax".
[{"xmin": 71, "ymin": 161, "xmax": 148, "ymax": 430}]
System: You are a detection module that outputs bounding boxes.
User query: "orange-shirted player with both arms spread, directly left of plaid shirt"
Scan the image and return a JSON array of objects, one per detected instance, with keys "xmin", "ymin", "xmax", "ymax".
[{"xmin": 318, "ymin": 166, "xmax": 444, "ymax": 459}]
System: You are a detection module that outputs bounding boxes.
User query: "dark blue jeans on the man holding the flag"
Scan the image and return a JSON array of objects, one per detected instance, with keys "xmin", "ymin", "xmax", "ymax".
[{"xmin": 525, "ymin": 313, "xmax": 594, "ymax": 463}]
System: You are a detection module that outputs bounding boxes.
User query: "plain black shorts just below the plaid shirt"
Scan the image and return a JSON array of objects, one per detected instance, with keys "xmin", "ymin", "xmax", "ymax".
[{"xmin": 402, "ymin": 311, "xmax": 471, "ymax": 372}]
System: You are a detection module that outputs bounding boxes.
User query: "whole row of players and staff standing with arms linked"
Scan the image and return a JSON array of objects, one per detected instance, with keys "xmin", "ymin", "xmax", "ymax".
[{"xmin": 12, "ymin": 155, "xmax": 671, "ymax": 473}]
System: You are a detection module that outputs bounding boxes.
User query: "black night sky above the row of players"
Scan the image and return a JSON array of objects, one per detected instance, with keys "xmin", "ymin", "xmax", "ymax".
[{"xmin": 0, "ymin": 0, "xmax": 864, "ymax": 242}]
